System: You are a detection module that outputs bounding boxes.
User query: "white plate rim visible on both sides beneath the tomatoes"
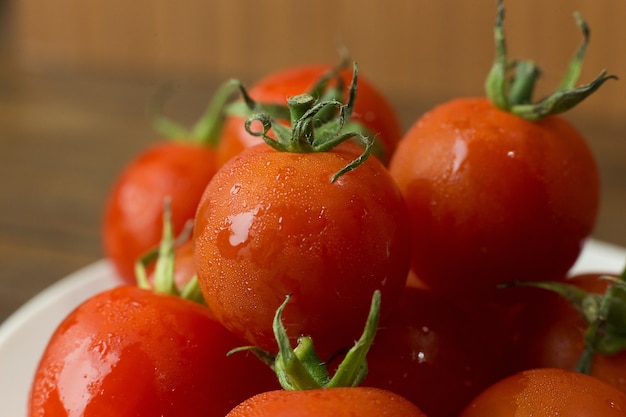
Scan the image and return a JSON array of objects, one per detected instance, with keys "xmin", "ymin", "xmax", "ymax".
[{"xmin": 0, "ymin": 240, "xmax": 626, "ymax": 417}]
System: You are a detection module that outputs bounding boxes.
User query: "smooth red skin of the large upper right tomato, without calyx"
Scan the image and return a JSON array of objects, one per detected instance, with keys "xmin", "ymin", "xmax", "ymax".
[{"xmin": 389, "ymin": 98, "xmax": 599, "ymax": 294}]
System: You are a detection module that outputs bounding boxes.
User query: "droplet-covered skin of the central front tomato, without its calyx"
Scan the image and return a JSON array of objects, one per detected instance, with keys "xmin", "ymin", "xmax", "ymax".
[{"xmin": 193, "ymin": 144, "xmax": 411, "ymax": 357}]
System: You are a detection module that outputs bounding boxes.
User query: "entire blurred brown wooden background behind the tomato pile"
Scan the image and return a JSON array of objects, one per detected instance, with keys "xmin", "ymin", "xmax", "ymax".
[{"xmin": 0, "ymin": 0, "xmax": 626, "ymax": 321}]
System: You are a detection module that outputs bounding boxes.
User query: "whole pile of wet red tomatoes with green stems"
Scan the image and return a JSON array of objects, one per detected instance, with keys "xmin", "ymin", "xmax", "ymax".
[{"xmin": 29, "ymin": 2, "xmax": 626, "ymax": 417}]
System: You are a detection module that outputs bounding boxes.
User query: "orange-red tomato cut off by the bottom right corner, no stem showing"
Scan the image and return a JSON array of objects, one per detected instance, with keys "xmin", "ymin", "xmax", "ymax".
[{"xmin": 459, "ymin": 368, "xmax": 626, "ymax": 417}]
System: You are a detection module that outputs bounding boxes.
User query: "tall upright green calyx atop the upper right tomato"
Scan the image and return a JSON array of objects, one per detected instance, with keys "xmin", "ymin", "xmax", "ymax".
[{"xmin": 485, "ymin": 0, "xmax": 617, "ymax": 121}]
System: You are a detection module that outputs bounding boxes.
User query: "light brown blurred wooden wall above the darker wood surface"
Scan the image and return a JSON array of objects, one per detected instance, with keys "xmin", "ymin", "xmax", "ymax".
[{"xmin": 8, "ymin": 0, "xmax": 626, "ymax": 119}]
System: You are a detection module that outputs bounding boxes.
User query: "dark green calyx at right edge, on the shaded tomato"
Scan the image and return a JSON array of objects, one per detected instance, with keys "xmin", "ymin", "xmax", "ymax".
[{"xmin": 510, "ymin": 264, "xmax": 626, "ymax": 373}]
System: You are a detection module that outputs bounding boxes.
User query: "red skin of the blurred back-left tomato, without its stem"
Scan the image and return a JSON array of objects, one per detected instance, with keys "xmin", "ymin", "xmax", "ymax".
[{"xmin": 102, "ymin": 141, "xmax": 216, "ymax": 283}]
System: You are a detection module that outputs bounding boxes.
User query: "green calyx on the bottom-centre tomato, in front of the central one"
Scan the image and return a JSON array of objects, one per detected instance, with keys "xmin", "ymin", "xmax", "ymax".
[{"xmin": 228, "ymin": 291, "xmax": 380, "ymax": 390}]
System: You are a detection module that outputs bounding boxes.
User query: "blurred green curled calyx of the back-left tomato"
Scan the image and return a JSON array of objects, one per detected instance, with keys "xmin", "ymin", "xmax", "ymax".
[{"xmin": 146, "ymin": 80, "xmax": 238, "ymax": 147}]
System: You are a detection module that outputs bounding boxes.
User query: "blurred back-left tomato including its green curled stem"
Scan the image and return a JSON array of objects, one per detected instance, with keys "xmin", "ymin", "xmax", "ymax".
[{"xmin": 102, "ymin": 82, "xmax": 237, "ymax": 284}]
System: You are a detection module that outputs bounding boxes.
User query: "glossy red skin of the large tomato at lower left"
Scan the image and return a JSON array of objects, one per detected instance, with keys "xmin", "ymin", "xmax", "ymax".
[{"xmin": 28, "ymin": 285, "xmax": 277, "ymax": 417}]
